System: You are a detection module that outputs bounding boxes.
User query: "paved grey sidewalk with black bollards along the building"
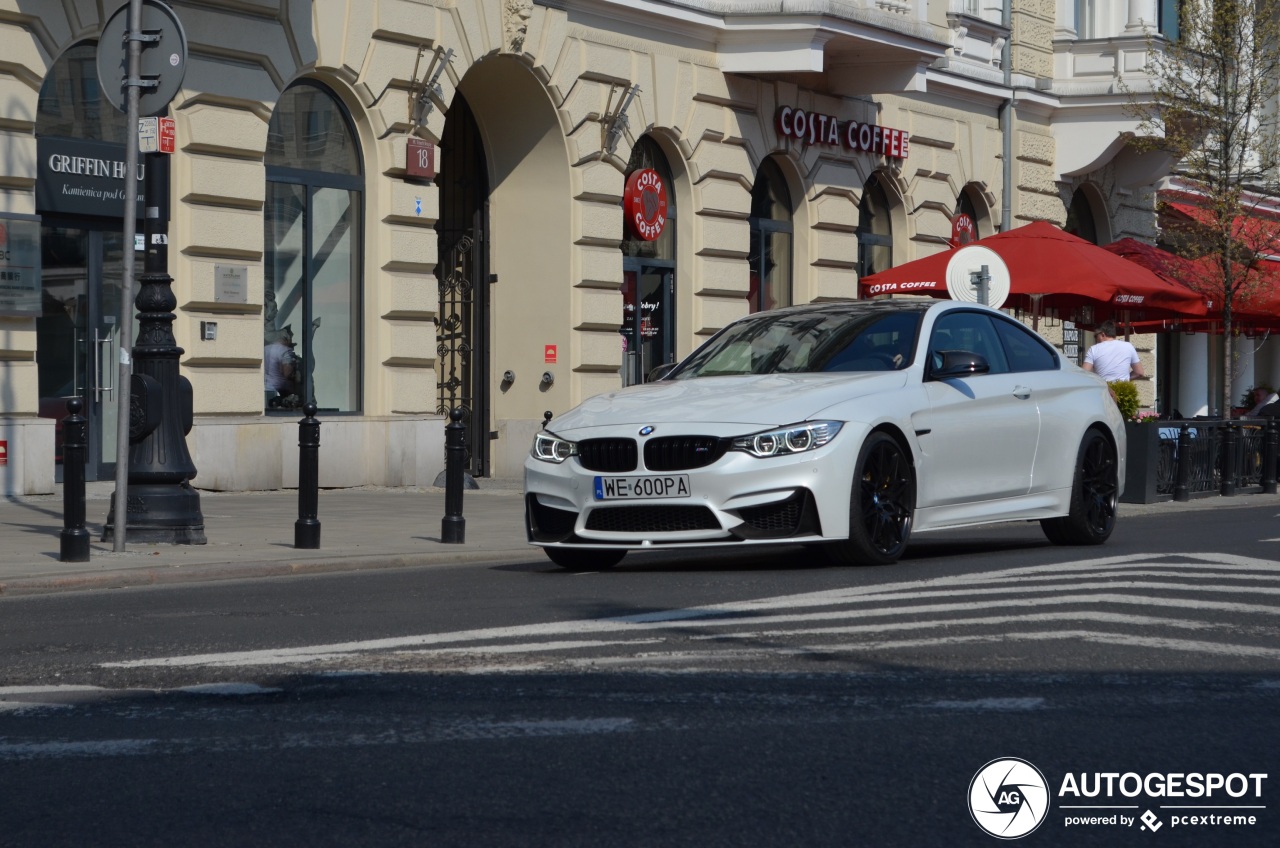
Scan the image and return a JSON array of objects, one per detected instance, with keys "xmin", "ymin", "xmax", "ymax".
[{"xmin": 0, "ymin": 480, "xmax": 1280, "ymax": 594}]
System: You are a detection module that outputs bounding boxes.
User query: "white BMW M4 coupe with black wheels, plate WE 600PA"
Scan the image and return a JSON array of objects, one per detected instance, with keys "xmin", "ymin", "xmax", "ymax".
[{"xmin": 525, "ymin": 300, "xmax": 1125, "ymax": 570}]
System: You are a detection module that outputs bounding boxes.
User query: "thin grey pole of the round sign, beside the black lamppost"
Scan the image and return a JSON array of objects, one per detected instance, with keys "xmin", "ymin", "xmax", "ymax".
[{"xmin": 111, "ymin": 0, "xmax": 142, "ymax": 553}]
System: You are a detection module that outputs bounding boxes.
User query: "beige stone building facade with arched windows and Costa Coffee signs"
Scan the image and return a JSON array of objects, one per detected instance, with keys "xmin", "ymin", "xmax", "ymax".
[{"xmin": 0, "ymin": 0, "xmax": 1155, "ymax": 493}]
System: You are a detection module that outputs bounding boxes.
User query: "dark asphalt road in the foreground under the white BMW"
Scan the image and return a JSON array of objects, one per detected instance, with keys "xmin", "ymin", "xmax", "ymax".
[{"xmin": 0, "ymin": 505, "xmax": 1280, "ymax": 845}]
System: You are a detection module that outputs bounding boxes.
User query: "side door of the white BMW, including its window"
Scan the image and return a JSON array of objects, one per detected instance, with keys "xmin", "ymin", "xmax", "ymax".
[{"xmin": 914, "ymin": 310, "xmax": 1039, "ymax": 507}]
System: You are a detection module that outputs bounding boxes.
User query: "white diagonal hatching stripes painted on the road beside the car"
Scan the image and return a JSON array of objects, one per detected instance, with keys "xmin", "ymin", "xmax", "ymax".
[{"xmin": 102, "ymin": 553, "xmax": 1280, "ymax": 667}]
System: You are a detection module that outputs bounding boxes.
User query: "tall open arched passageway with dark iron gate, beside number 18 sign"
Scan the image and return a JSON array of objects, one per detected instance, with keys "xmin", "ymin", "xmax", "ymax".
[{"xmin": 435, "ymin": 55, "xmax": 576, "ymax": 477}]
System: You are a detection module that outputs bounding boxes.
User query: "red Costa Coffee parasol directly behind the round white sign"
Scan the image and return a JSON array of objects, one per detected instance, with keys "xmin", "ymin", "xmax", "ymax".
[{"xmin": 859, "ymin": 222, "xmax": 1206, "ymax": 318}]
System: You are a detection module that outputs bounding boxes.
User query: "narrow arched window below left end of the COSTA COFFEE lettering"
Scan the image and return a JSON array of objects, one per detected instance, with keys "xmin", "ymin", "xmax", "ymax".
[{"xmin": 748, "ymin": 159, "xmax": 792, "ymax": 313}]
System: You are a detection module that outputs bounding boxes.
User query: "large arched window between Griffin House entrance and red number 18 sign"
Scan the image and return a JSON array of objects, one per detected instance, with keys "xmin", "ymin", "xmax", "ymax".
[{"xmin": 262, "ymin": 82, "xmax": 365, "ymax": 412}]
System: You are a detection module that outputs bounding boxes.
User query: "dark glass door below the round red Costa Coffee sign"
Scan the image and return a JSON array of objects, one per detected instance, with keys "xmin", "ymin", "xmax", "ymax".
[{"xmin": 621, "ymin": 263, "xmax": 676, "ymax": 386}]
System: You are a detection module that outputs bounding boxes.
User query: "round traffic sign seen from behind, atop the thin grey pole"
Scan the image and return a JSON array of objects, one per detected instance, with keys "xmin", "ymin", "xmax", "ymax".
[{"xmin": 97, "ymin": 0, "xmax": 187, "ymax": 117}]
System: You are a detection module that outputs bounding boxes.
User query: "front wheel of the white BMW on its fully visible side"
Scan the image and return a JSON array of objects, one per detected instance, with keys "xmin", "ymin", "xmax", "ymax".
[{"xmin": 827, "ymin": 433, "xmax": 915, "ymax": 565}]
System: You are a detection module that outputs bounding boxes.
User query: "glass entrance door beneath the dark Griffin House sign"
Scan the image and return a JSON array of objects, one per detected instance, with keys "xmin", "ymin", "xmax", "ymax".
[{"xmin": 36, "ymin": 224, "xmax": 124, "ymax": 482}]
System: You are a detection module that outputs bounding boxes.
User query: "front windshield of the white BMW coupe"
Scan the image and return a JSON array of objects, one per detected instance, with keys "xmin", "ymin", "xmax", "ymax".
[{"xmin": 668, "ymin": 310, "xmax": 920, "ymax": 379}]
